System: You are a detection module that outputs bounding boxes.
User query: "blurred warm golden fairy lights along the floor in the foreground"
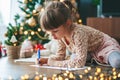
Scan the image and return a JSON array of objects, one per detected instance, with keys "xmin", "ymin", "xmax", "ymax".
[{"xmin": 8, "ymin": 67, "xmax": 120, "ymax": 80}]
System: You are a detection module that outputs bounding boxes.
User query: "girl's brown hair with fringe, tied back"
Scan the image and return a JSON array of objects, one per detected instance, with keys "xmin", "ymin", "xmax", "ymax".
[{"xmin": 40, "ymin": 1, "xmax": 71, "ymax": 30}]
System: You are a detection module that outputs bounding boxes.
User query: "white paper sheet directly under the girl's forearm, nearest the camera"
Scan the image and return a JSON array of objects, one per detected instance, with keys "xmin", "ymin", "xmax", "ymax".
[{"xmin": 30, "ymin": 65, "xmax": 88, "ymax": 71}]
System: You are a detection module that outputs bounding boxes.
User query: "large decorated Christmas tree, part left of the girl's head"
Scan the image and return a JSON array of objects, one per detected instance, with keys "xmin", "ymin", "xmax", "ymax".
[{"xmin": 18, "ymin": 0, "xmax": 49, "ymax": 44}]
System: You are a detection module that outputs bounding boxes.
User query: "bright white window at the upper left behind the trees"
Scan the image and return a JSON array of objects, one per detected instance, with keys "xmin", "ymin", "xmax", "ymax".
[{"xmin": 0, "ymin": 0, "xmax": 20, "ymax": 42}]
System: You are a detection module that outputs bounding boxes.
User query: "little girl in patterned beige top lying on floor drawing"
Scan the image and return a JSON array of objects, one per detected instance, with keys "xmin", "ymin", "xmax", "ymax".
[{"xmin": 39, "ymin": 1, "xmax": 120, "ymax": 68}]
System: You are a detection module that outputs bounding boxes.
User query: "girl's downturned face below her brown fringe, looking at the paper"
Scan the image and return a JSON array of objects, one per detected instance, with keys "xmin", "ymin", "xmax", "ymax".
[{"xmin": 47, "ymin": 25, "xmax": 67, "ymax": 40}]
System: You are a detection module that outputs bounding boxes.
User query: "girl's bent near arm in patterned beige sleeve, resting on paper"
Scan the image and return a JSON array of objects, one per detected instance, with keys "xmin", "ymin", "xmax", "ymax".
[{"xmin": 48, "ymin": 30, "xmax": 88, "ymax": 67}]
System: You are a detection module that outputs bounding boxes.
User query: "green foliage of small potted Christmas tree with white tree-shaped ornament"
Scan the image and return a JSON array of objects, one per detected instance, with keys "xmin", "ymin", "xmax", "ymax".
[{"xmin": 5, "ymin": 14, "xmax": 24, "ymax": 46}]
